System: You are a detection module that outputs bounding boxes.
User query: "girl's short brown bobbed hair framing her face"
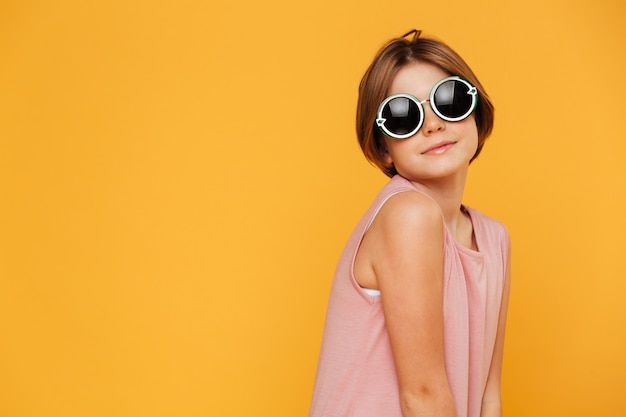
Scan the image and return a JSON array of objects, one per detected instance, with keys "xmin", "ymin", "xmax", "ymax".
[{"xmin": 356, "ymin": 30, "xmax": 494, "ymax": 177}]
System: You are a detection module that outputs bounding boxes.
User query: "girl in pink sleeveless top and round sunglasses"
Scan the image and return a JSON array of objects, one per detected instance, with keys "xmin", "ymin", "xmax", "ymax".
[{"xmin": 310, "ymin": 30, "xmax": 510, "ymax": 417}]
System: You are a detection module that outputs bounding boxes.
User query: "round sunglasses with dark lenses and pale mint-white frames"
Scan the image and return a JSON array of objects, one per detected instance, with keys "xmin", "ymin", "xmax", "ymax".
[{"xmin": 376, "ymin": 75, "xmax": 478, "ymax": 139}]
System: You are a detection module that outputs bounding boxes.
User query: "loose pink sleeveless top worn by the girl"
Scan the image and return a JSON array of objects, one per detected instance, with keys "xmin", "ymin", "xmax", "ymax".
[{"xmin": 309, "ymin": 176, "xmax": 509, "ymax": 417}]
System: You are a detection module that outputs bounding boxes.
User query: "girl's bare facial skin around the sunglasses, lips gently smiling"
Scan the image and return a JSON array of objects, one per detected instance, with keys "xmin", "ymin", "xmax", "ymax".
[{"xmin": 385, "ymin": 62, "xmax": 480, "ymax": 182}]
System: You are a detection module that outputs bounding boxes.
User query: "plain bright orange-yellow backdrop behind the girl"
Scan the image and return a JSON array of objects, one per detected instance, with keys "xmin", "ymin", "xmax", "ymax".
[{"xmin": 0, "ymin": 0, "xmax": 626, "ymax": 417}]
